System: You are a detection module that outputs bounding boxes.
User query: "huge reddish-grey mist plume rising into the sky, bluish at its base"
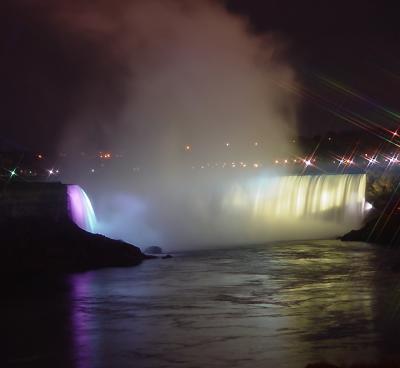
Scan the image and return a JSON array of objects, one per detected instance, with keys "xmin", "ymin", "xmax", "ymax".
[{"xmin": 50, "ymin": 0, "xmax": 304, "ymax": 249}]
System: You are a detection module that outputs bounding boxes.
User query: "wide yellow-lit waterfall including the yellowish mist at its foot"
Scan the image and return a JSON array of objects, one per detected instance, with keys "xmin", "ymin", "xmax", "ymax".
[{"xmin": 222, "ymin": 174, "xmax": 366, "ymax": 239}]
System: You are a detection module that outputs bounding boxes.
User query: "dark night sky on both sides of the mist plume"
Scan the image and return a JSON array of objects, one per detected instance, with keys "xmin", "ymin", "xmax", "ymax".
[{"xmin": 0, "ymin": 0, "xmax": 400, "ymax": 149}]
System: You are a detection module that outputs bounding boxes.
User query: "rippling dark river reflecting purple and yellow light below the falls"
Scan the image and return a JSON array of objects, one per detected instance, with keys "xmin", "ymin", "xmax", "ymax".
[{"xmin": 0, "ymin": 241, "xmax": 400, "ymax": 368}]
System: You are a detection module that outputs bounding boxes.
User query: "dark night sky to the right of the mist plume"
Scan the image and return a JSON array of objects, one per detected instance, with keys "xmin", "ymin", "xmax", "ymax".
[{"xmin": 228, "ymin": 0, "xmax": 400, "ymax": 134}]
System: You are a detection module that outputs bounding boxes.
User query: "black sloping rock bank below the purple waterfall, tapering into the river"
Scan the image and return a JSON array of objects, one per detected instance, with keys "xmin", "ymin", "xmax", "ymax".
[{"xmin": 0, "ymin": 218, "xmax": 151, "ymax": 274}]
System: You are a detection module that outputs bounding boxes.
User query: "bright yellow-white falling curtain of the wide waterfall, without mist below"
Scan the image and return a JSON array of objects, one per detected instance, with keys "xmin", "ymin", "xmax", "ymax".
[{"xmin": 224, "ymin": 174, "xmax": 366, "ymax": 222}]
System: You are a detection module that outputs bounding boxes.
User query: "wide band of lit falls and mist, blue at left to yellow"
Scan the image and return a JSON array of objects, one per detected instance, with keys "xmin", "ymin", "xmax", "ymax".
[{"xmin": 92, "ymin": 171, "xmax": 366, "ymax": 247}]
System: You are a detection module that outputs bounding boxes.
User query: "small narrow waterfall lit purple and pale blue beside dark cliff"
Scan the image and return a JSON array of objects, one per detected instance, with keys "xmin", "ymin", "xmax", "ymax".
[{"xmin": 67, "ymin": 185, "xmax": 96, "ymax": 233}]
